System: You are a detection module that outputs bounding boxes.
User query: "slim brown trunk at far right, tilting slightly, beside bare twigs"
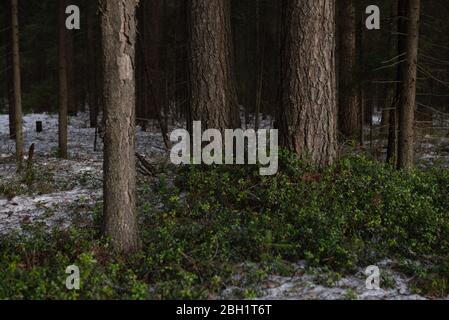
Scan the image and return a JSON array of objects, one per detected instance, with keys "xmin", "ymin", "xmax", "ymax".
[{"xmin": 398, "ymin": 0, "xmax": 421, "ymax": 170}]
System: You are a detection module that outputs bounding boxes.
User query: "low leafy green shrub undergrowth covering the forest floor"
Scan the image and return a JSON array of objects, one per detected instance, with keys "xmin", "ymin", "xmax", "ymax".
[{"xmin": 0, "ymin": 153, "xmax": 449, "ymax": 299}]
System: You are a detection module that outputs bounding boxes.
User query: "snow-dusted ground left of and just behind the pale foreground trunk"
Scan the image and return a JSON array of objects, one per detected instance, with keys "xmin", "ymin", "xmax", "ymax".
[{"xmin": 0, "ymin": 113, "xmax": 170, "ymax": 233}]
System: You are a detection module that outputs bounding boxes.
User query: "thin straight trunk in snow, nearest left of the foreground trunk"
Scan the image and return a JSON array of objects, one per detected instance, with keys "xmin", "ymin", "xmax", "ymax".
[{"xmin": 58, "ymin": 0, "xmax": 69, "ymax": 158}]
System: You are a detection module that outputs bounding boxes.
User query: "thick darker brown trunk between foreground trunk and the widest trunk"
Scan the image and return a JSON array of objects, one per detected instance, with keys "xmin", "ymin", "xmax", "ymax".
[{"xmin": 189, "ymin": 0, "xmax": 240, "ymax": 130}]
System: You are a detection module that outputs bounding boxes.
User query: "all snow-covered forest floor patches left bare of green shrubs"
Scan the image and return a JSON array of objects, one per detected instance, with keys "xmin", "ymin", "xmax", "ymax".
[{"xmin": 0, "ymin": 113, "xmax": 449, "ymax": 299}]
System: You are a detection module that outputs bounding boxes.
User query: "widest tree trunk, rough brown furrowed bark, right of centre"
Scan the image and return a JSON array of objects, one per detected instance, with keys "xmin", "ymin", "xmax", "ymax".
[{"xmin": 278, "ymin": 0, "xmax": 337, "ymax": 167}]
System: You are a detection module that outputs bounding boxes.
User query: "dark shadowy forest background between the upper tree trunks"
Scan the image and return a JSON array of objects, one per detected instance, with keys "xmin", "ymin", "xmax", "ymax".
[{"xmin": 0, "ymin": 0, "xmax": 449, "ymax": 125}]
